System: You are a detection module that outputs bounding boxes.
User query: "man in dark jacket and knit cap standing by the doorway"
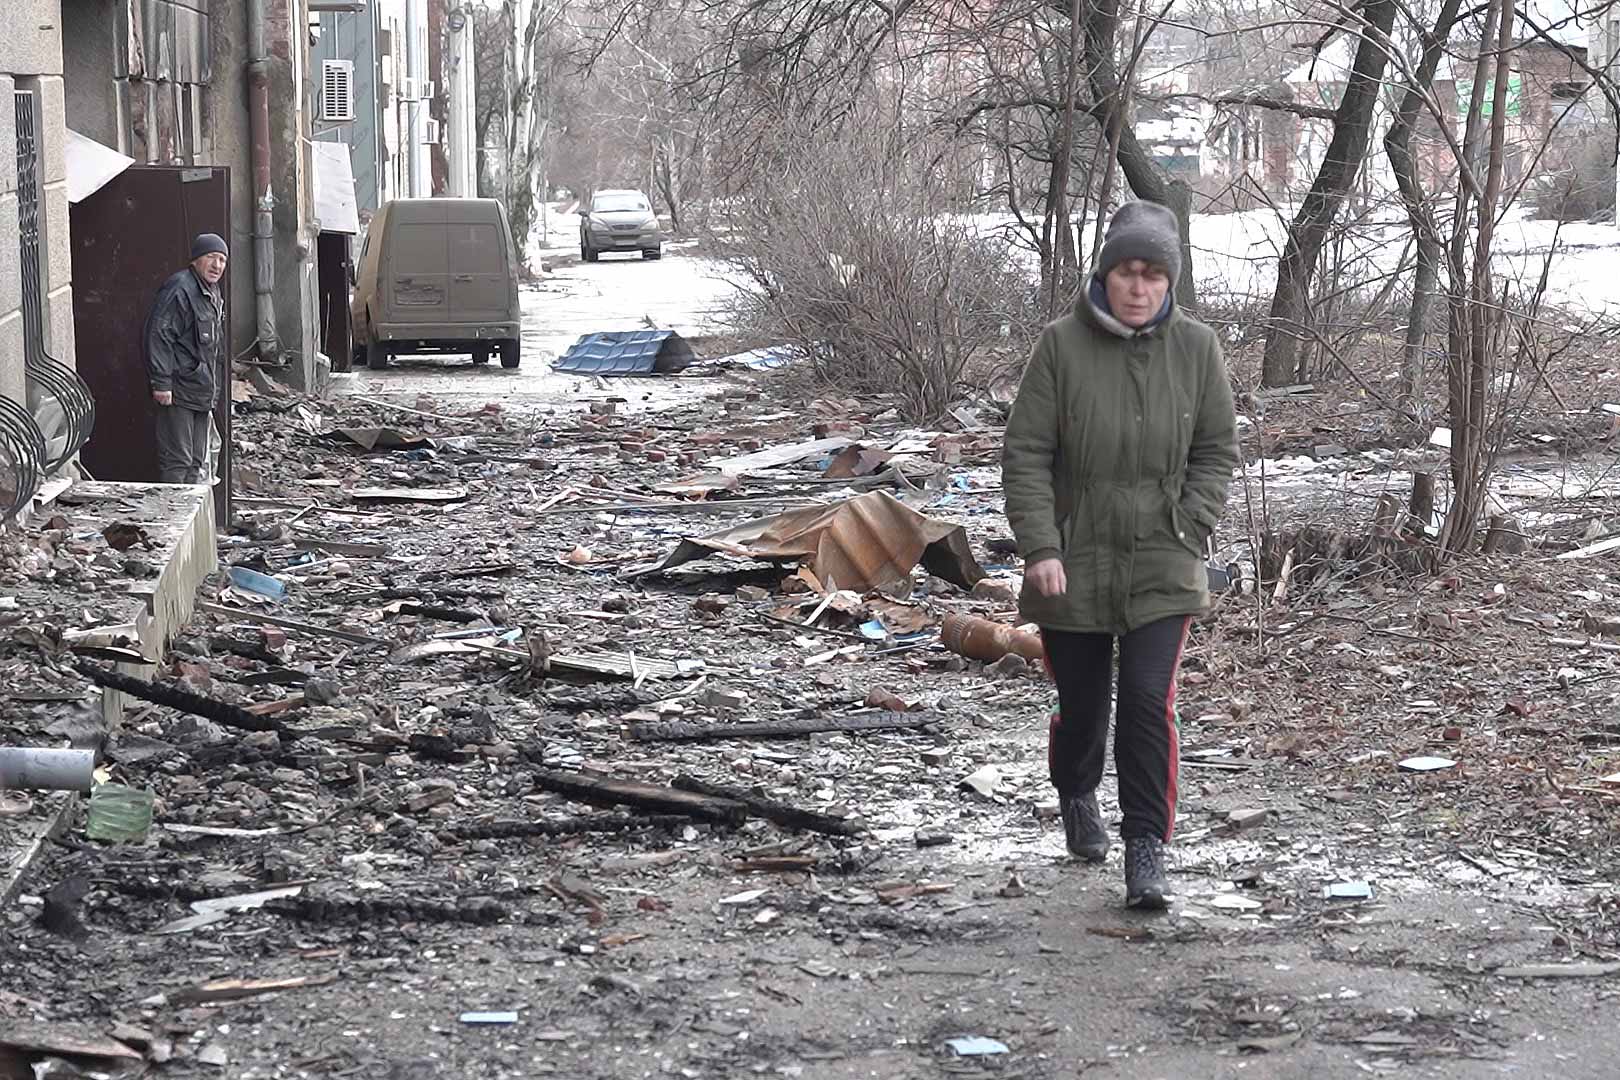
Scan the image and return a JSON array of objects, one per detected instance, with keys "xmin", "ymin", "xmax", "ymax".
[{"xmin": 144, "ymin": 233, "xmax": 228, "ymax": 484}]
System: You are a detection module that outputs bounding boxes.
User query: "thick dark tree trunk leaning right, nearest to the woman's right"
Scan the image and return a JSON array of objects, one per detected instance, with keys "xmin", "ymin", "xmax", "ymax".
[{"xmin": 1260, "ymin": 0, "xmax": 1396, "ymax": 387}]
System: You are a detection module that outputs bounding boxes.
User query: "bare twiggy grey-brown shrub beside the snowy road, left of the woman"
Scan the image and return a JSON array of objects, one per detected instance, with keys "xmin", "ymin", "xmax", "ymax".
[{"xmin": 718, "ymin": 122, "xmax": 1038, "ymax": 421}]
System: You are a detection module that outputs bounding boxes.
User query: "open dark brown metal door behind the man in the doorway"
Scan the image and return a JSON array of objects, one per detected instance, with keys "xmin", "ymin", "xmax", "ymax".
[{"xmin": 70, "ymin": 165, "xmax": 233, "ymax": 526}]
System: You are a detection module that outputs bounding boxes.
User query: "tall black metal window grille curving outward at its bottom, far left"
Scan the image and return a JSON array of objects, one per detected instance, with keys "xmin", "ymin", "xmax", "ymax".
[{"xmin": 15, "ymin": 91, "xmax": 96, "ymax": 476}]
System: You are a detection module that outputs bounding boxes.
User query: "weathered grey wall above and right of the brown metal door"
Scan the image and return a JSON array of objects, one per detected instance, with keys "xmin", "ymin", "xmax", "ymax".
[{"xmin": 60, "ymin": 0, "xmax": 319, "ymax": 389}]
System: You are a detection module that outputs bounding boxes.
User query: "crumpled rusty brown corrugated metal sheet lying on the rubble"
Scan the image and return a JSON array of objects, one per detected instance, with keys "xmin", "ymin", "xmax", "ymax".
[{"xmin": 630, "ymin": 491, "xmax": 985, "ymax": 593}]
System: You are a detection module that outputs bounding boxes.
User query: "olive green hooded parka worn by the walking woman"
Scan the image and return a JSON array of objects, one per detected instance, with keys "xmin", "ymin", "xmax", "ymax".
[{"xmin": 1001, "ymin": 285, "xmax": 1238, "ymax": 635}]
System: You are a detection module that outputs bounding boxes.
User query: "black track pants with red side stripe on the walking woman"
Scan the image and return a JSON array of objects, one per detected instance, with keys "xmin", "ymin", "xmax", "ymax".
[{"xmin": 1042, "ymin": 615, "xmax": 1192, "ymax": 840}]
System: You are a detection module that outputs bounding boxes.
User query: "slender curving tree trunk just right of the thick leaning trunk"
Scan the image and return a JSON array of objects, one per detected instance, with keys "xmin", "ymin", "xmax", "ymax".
[{"xmin": 1383, "ymin": 0, "xmax": 1463, "ymax": 421}]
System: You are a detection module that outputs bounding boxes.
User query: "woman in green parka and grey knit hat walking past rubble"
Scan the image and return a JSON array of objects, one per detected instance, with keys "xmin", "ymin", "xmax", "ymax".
[{"xmin": 1001, "ymin": 202, "xmax": 1238, "ymax": 908}]
